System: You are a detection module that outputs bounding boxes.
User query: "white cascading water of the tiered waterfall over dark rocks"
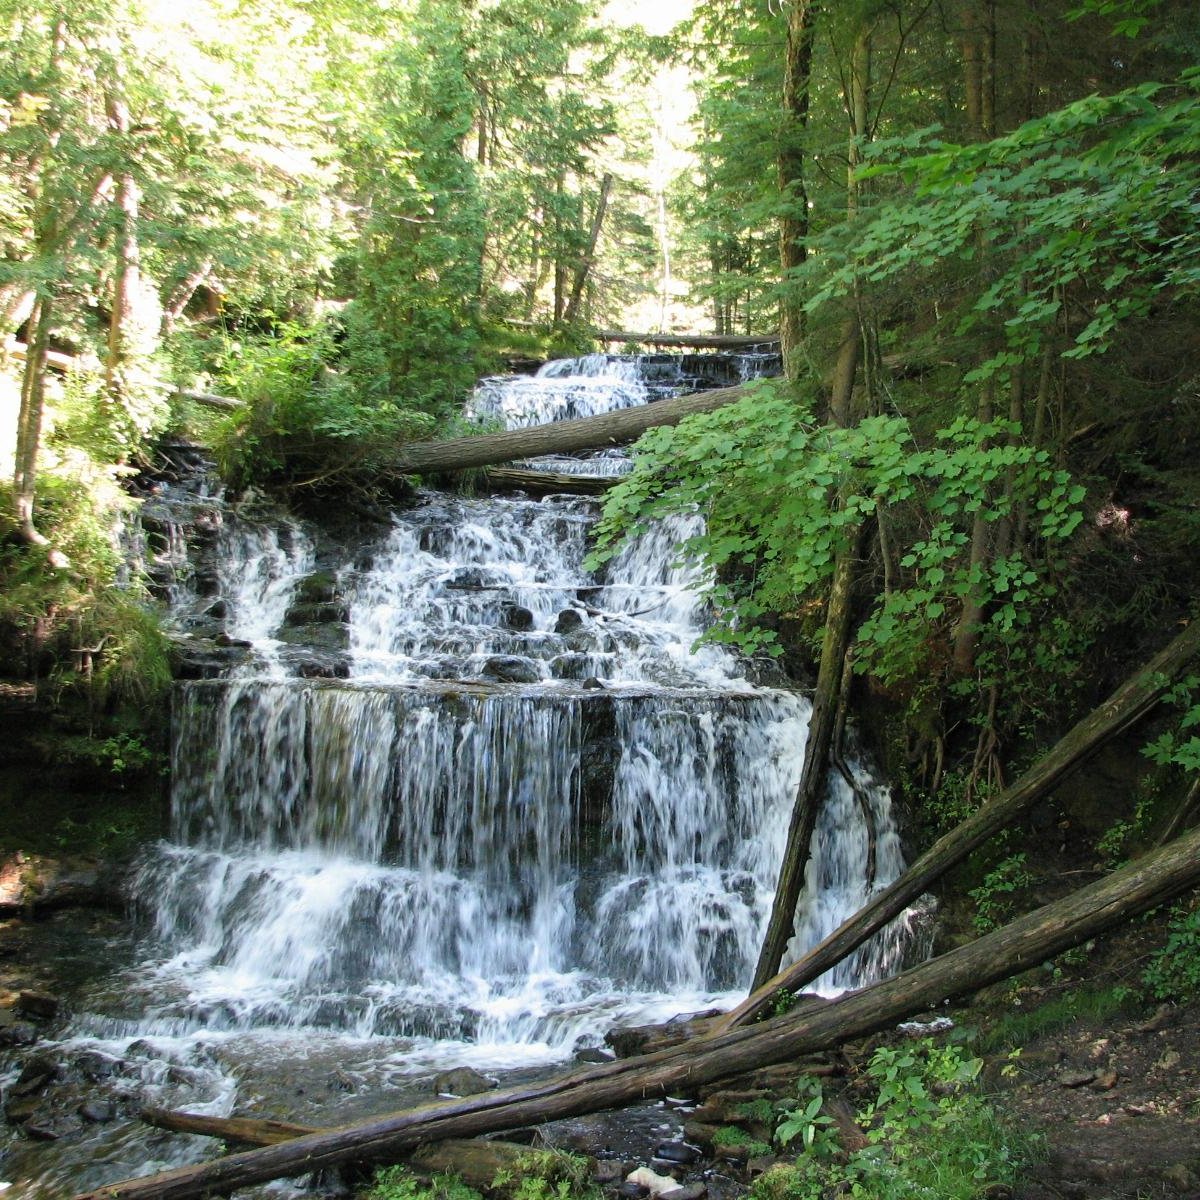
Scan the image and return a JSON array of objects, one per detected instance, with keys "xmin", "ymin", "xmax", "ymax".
[{"xmin": 0, "ymin": 356, "xmax": 921, "ymax": 1196}]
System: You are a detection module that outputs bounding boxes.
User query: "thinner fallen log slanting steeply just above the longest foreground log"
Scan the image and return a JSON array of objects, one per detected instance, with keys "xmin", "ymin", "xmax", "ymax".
[{"xmin": 713, "ymin": 620, "xmax": 1200, "ymax": 1034}]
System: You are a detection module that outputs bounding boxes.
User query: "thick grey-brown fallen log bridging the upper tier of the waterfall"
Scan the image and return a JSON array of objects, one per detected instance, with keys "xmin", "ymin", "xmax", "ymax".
[{"xmin": 391, "ymin": 388, "xmax": 745, "ymax": 475}]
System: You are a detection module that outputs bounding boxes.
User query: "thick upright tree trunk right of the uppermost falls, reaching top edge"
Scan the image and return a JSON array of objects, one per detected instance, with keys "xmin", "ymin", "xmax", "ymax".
[{"xmin": 778, "ymin": 0, "xmax": 816, "ymax": 380}]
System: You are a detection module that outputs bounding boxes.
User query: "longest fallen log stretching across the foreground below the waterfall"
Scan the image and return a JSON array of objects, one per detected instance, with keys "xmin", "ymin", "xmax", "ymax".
[{"xmin": 77, "ymin": 830, "xmax": 1200, "ymax": 1200}]
